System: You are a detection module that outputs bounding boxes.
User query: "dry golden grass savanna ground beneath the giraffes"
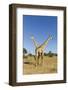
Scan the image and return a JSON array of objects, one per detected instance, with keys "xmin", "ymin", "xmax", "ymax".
[{"xmin": 23, "ymin": 56, "xmax": 57, "ymax": 75}]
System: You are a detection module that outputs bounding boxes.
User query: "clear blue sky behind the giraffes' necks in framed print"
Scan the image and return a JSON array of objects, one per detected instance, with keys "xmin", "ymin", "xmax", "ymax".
[{"xmin": 23, "ymin": 15, "xmax": 57, "ymax": 54}]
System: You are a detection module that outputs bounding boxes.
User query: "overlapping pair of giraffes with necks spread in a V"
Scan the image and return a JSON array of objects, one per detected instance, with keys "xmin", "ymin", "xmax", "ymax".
[{"xmin": 31, "ymin": 35, "xmax": 52, "ymax": 66}]
